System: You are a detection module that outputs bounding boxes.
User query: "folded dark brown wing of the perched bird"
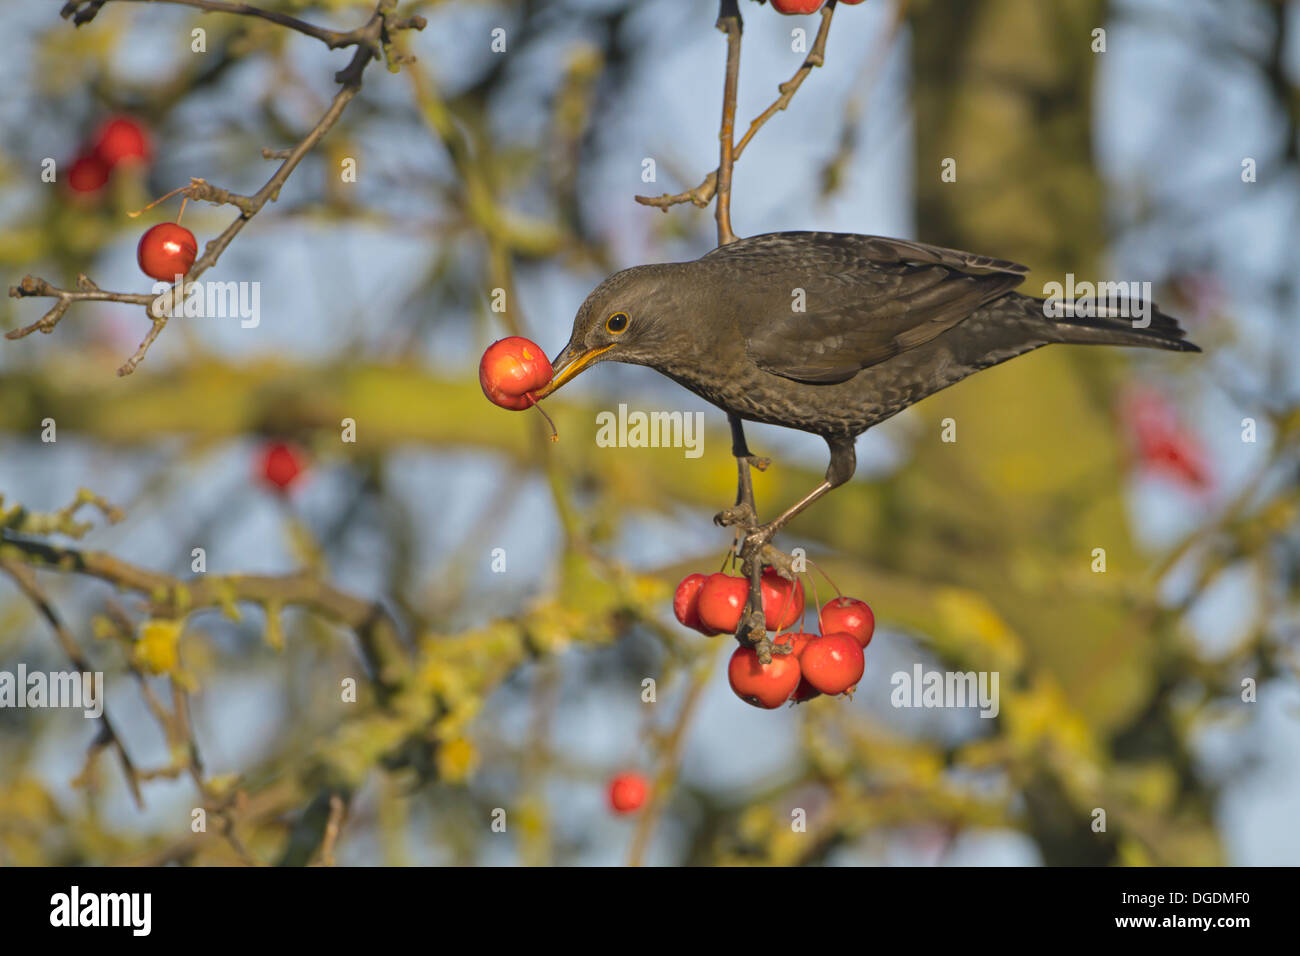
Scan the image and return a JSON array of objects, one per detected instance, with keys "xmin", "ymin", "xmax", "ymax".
[{"xmin": 701, "ymin": 233, "xmax": 1028, "ymax": 384}]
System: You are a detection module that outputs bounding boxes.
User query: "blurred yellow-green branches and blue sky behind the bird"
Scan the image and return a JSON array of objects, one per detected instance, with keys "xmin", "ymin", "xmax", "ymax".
[{"xmin": 0, "ymin": 0, "xmax": 1300, "ymax": 865}]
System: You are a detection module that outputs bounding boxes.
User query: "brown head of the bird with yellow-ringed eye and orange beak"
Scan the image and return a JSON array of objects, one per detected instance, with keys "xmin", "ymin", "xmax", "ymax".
[{"xmin": 533, "ymin": 263, "xmax": 685, "ymax": 398}]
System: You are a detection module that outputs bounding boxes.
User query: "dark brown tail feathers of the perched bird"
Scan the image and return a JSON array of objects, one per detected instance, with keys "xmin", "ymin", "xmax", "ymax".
[{"xmin": 1009, "ymin": 293, "xmax": 1200, "ymax": 352}]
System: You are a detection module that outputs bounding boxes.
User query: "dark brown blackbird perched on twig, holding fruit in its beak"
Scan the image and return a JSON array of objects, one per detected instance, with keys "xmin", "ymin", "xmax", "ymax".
[{"xmin": 534, "ymin": 232, "xmax": 1200, "ymax": 548}]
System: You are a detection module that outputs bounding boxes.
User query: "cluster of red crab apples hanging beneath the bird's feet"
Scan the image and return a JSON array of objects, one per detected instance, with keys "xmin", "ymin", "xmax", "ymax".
[{"xmin": 672, "ymin": 567, "xmax": 876, "ymax": 710}]
